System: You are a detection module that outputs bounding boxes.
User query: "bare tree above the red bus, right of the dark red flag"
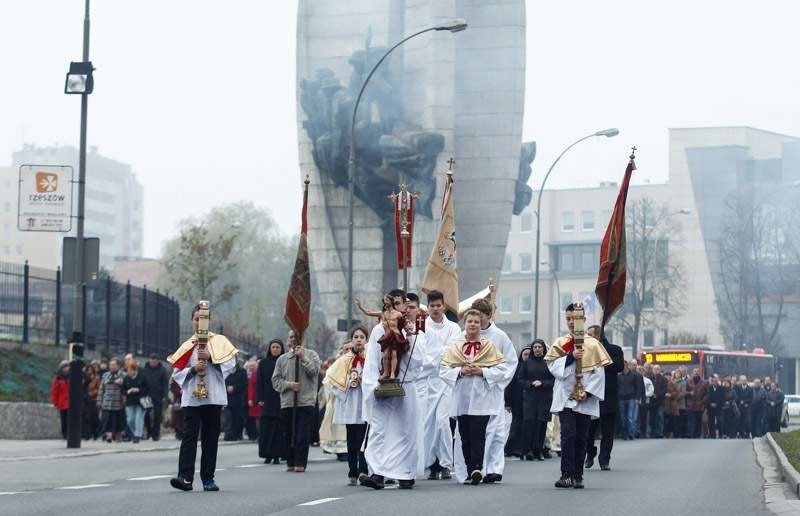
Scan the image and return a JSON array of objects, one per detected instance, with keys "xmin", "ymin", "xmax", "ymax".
[{"xmin": 611, "ymin": 197, "xmax": 686, "ymax": 356}]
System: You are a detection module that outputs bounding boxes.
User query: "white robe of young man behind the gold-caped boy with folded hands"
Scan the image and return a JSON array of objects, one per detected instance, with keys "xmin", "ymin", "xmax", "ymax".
[{"xmin": 451, "ymin": 323, "xmax": 519, "ymax": 480}]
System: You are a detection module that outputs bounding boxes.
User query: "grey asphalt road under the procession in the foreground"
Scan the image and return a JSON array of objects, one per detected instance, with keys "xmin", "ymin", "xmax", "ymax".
[{"xmin": 0, "ymin": 440, "xmax": 771, "ymax": 516}]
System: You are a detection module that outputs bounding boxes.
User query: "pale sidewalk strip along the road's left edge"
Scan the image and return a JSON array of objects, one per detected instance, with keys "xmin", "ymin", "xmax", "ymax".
[{"xmin": 0, "ymin": 434, "xmax": 256, "ymax": 463}]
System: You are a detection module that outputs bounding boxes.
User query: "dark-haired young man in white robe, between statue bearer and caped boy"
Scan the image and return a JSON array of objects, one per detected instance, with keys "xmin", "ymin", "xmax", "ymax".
[{"xmin": 417, "ymin": 290, "xmax": 461, "ymax": 480}]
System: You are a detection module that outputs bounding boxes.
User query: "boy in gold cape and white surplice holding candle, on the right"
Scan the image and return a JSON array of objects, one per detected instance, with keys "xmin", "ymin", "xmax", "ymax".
[{"xmin": 544, "ymin": 303, "xmax": 611, "ymax": 489}]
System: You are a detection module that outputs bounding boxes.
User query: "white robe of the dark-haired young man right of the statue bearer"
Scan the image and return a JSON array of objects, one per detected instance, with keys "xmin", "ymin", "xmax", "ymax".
[{"xmin": 417, "ymin": 316, "xmax": 461, "ymax": 470}]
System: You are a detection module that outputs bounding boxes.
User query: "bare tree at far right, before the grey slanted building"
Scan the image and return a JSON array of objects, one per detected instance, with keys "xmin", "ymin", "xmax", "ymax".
[{"xmin": 718, "ymin": 194, "xmax": 800, "ymax": 353}]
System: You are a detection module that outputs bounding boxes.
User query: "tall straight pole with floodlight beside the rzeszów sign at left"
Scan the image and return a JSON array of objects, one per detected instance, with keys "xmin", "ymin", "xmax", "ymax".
[{"xmin": 63, "ymin": 0, "xmax": 94, "ymax": 448}]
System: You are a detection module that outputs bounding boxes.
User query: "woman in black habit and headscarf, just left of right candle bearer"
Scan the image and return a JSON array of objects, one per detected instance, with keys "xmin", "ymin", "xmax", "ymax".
[{"xmin": 517, "ymin": 339, "xmax": 555, "ymax": 460}]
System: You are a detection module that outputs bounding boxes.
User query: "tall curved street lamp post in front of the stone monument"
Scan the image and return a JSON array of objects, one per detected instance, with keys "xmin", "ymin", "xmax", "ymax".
[{"xmin": 347, "ymin": 18, "xmax": 467, "ymax": 327}]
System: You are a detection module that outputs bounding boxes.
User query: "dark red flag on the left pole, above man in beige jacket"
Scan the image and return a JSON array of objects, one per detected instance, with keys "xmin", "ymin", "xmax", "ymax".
[{"xmin": 284, "ymin": 178, "xmax": 311, "ymax": 343}]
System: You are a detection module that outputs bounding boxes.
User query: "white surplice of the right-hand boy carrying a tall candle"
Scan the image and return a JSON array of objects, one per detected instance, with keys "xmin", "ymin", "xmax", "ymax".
[{"xmin": 547, "ymin": 355, "xmax": 606, "ymax": 419}]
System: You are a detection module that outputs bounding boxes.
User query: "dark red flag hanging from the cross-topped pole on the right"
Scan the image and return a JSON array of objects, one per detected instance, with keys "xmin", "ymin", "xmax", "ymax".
[{"xmin": 595, "ymin": 154, "xmax": 636, "ymax": 326}]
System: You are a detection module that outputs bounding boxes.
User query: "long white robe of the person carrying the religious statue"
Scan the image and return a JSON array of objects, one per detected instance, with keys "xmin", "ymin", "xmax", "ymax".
[{"xmin": 361, "ymin": 324, "xmax": 424, "ymax": 480}]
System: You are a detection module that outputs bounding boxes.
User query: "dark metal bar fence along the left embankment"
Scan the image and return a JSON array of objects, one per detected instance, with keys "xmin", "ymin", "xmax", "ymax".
[{"xmin": 0, "ymin": 262, "xmax": 180, "ymax": 356}]
